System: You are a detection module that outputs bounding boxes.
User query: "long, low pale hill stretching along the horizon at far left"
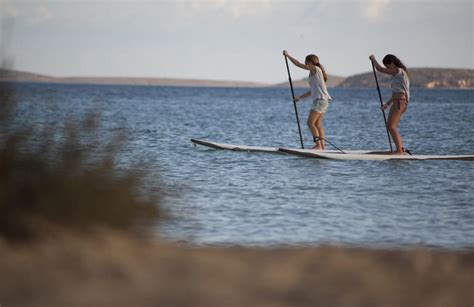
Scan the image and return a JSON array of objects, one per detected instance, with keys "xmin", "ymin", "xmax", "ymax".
[{"xmin": 0, "ymin": 69, "xmax": 269, "ymax": 87}]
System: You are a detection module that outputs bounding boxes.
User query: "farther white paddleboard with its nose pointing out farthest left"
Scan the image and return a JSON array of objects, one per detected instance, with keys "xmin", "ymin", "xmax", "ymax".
[{"xmin": 191, "ymin": 139, "xmax": 382, "ymax": 154}]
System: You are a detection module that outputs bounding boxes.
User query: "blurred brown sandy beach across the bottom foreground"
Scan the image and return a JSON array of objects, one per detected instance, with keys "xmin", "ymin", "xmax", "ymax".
[{"xmin": 0, "ymin": 232, "xmax": 474, "ymax": 307}]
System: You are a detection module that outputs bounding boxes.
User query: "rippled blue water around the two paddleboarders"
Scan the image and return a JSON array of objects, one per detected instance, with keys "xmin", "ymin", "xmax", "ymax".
[{"xmin": 10, "ymin": 84, "xmax": 474, "ymax": 248}]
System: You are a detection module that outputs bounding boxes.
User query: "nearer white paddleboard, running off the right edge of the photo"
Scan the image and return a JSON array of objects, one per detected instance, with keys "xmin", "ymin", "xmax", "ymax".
[{"xmin": 278, "ymin": 148, "xmax": 474, "ymax": 161}]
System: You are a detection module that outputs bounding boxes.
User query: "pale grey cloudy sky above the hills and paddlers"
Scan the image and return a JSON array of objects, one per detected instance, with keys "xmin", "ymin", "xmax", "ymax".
[{"xmin": 0, "ymin": 0, "xmax": 474, "ymax": 83}]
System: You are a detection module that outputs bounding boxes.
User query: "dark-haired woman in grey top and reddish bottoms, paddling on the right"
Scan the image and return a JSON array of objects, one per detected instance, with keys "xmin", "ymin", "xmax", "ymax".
[{"xmin": 369, "ymin": 54, "xmax": 410, "ymax": 155}]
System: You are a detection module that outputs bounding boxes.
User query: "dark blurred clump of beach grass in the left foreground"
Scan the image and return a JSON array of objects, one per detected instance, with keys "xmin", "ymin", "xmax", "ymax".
[{"xmin": 0, "ymin": 77, "xmax": 162, "ymax": 241}]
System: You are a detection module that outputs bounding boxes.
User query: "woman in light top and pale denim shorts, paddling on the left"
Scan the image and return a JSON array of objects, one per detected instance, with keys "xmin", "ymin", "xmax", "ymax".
[{"xmin": 283, "ymin": 50, "xmax": 332, "ymax": 150}]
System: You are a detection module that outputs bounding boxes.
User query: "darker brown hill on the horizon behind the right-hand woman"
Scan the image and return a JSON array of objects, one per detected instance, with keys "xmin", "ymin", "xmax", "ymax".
[{"xmin": 339, "ymin": 68, "xmax": 474, "ymax": 88}]
